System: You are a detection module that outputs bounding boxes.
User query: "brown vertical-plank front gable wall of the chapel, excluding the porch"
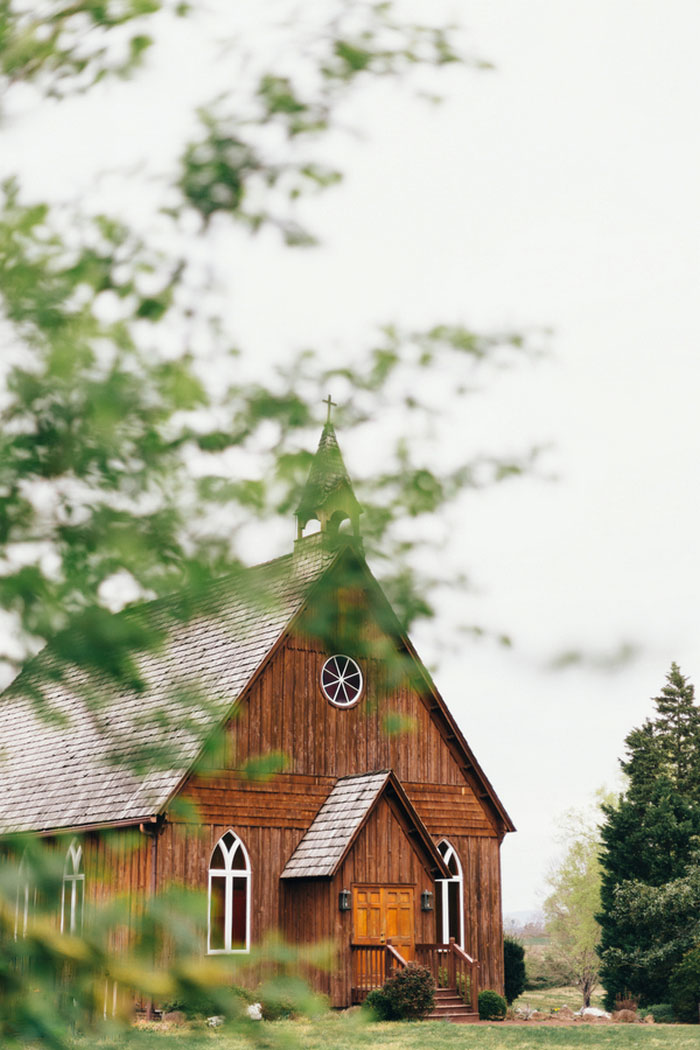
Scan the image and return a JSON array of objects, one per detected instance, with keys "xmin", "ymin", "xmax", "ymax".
[{"xmin": 173, "ymin": 613, "xmax": 510, "ymax": 1000}]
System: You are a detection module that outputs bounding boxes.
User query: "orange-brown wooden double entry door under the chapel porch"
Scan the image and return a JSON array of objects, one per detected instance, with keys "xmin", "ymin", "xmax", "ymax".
[{"xmin": 353, "ymin": 886, "xmax": 416, "ymax": 960}]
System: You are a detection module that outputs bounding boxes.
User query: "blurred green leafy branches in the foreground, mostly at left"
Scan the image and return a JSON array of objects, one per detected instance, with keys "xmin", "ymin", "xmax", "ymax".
[{"xmin": 0, "ymin": 0, "xmax": 530, "ymax": 1048}]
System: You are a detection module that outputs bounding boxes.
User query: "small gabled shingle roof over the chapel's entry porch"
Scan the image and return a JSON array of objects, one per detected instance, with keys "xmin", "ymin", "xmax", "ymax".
[{"xmin": 280, "ymin": 770, "xmax": 449, "ymax": 879}]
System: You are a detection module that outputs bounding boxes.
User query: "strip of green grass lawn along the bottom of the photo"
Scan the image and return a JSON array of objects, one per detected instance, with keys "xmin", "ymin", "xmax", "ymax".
[{"xmin": 76, "ymin": 1013, "xmax": 700, "ymax": 1050}]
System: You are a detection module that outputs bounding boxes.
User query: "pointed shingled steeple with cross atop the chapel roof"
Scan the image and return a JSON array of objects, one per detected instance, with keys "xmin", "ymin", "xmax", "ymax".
[{"xmin": 296, "ymin": 396, "xmax": 362, "ymax": 540}]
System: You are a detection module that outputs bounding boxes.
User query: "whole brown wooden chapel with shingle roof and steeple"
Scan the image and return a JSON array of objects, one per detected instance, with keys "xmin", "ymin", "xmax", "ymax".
[{"xmin": 0, "ymin": 419, "xmax": 514, "ymax": 1015}]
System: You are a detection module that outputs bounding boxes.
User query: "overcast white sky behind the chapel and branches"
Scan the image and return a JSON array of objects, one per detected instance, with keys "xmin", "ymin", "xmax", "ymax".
[{"xmin": 5, "ymin": 0, "xmax": 700, "ymax": 912}]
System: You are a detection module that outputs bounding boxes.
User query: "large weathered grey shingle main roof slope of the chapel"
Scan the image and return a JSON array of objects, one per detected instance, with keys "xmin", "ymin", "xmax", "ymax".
[{"xmin": 0, "ymin": 543, "xmax": 333, "ymax": 834}]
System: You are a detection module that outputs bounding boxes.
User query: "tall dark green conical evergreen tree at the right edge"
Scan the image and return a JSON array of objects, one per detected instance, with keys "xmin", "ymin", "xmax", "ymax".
[{"xmin": 599, "ymin": 664, "xmax": 700, "ymax": 1008}]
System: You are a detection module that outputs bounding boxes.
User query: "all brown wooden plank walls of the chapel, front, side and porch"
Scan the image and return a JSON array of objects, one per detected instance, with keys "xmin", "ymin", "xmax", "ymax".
[{"xmin": 58, "ymin": 583, "xmax": 510, "ymax": 1005}]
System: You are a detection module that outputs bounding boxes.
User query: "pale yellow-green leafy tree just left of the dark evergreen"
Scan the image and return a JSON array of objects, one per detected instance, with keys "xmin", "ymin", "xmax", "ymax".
[{"xmin": 544, "ymin": 814, "xmax": 600, "ymax": 1006}]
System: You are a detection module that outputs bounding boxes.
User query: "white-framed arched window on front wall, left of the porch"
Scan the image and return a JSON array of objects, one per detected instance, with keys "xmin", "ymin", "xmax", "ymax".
[{"xmin": 207, "ymin": 832, "xmax": 251, "ymax": 954}]
